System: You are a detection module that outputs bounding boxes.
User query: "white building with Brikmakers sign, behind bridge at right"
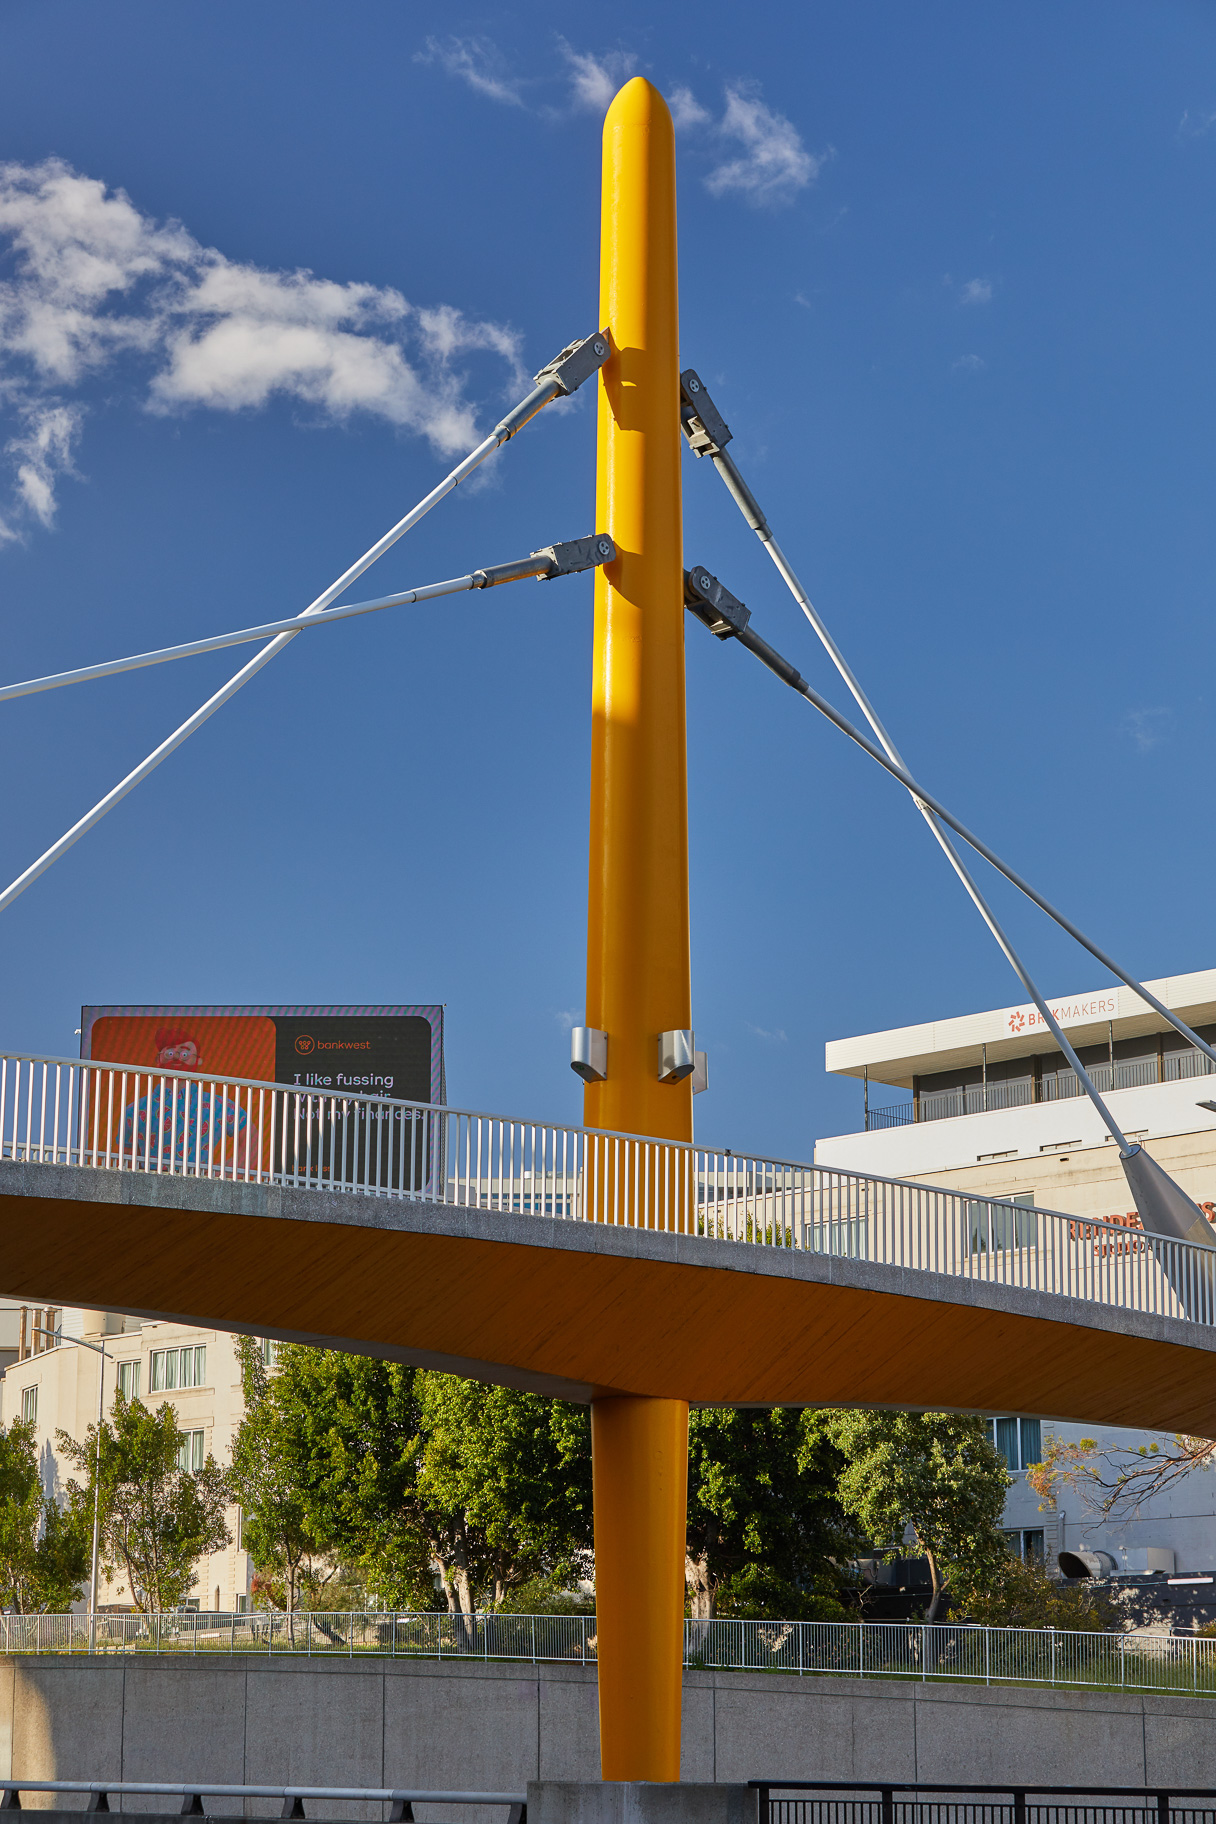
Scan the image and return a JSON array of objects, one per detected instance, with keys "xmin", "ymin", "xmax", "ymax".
[{"xmin": 815, "ymin": 969, "xmax": 1216, "ymax": 1574}]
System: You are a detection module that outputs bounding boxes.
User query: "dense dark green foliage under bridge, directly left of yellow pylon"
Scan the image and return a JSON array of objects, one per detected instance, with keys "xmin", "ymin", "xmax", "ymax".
[{"xmin": 273, "ymin": 1348, "xmax": 591, "ymax": 1614}]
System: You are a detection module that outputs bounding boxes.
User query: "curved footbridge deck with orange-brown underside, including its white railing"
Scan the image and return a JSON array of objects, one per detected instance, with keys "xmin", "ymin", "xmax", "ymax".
[{"xmin": 0, "ymin": 1054, "xmax": 1216, "ymax": 1437}]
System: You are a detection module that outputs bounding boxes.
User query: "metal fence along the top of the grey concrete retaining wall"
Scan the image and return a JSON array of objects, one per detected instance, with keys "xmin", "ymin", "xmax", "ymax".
[{"xmin": 0, "ymin": 1609, "xmax": 1216, "ymax": 1696}]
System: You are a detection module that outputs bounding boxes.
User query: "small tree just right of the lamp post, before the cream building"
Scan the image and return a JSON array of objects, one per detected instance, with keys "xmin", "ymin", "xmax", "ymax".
[{"xmin": 58, "ymin": 1392, "xmax": 232, "ymax": 1612}]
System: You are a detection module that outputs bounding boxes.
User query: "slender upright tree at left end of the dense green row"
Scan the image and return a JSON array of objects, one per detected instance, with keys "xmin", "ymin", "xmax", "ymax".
[{"xmin": 228, "ymin": 1337, "xmax": 332, "ymax": 1614}]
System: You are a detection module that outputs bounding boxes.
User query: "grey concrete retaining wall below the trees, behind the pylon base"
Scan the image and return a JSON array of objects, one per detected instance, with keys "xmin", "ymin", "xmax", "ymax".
[{"xmin": 0, "ymin": 1656, "xmax": 1216, "ymax": 1802}]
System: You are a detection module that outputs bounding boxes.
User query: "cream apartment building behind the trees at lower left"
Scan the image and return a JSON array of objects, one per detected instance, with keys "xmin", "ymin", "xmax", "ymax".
[{"xmin": 0, "ymin": 1301, "xmax": 257, "ymax": 1612}]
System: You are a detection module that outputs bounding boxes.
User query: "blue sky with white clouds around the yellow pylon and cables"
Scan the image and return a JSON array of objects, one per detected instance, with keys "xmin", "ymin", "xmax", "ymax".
[{"xmin": 0, "ymin": 0, "xmax": 1216, "ymax": 1156}]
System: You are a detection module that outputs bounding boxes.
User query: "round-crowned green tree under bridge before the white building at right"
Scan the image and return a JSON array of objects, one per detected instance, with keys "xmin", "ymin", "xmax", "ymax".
[{"xmin": 817, "ymin": 1410, "xmax": 1012, "ymax": 1622}]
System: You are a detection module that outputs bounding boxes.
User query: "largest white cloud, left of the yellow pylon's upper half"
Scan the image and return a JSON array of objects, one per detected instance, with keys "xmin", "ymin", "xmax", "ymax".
[{"xmin": 0, "ymin": 159, "xmax": 525, "ymax": 542}]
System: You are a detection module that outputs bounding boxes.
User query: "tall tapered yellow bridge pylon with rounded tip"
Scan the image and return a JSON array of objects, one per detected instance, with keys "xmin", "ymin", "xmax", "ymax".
[{"xmin": 583, "ymin": 78, "xmax": 693, "ymax": 1780}]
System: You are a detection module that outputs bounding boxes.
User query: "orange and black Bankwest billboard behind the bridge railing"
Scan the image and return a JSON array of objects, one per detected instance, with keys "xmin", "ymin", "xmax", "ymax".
[{"xmin": 80, "ymin": 1007, "xmax": 447, "ymax": 1187}]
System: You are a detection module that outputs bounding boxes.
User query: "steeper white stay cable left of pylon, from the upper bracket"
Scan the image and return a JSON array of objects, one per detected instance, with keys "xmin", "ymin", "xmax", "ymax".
[{"xmin": 0, "ymin": 330, "xmax": 611, "ymax": 912}]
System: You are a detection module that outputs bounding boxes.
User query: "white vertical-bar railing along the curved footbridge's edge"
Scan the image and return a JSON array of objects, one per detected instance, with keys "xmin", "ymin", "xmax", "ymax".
[{"xmin": 0, "ymin": 1052, "xmax": 1216, "ymax": 1324}]
